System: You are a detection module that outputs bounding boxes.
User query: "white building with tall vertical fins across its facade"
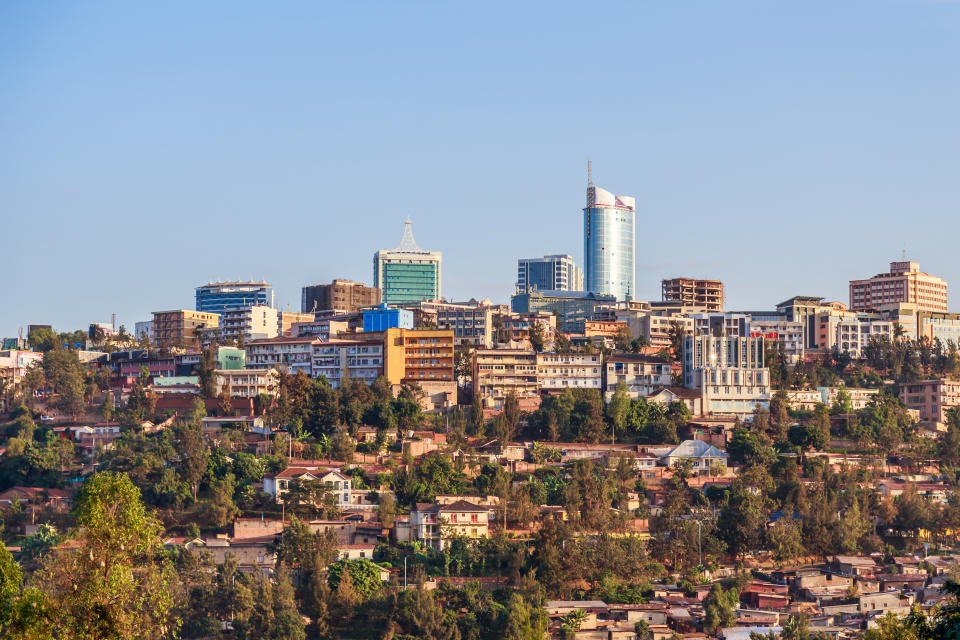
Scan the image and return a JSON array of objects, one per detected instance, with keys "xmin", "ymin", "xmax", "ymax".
[{"xmin": 683, "ymin": 336, "xmax": 770, "ymax": 416}]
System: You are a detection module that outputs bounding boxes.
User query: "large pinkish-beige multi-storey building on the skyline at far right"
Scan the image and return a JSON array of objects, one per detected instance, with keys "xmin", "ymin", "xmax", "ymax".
[{"xmin": 850, "ymin": 260, "xmax": 947, "ymax": 313}]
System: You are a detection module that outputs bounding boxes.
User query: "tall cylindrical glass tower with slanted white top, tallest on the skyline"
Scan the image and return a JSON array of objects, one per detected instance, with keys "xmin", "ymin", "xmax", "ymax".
[{"xmin": 583, "ymin": 185, "xmax": 637, "ymax": 300}]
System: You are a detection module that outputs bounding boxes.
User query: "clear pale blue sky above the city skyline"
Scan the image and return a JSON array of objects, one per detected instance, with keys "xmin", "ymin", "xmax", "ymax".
[{"xmin": 0, "ymin": 0, "xmax": 960, "ymax": 335}]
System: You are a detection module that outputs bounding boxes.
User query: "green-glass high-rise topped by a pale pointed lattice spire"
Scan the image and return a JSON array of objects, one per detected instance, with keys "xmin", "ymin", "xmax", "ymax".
[{"xmin": 373, "ymin": 220, "xmax": 442, "ymax": 304}]
